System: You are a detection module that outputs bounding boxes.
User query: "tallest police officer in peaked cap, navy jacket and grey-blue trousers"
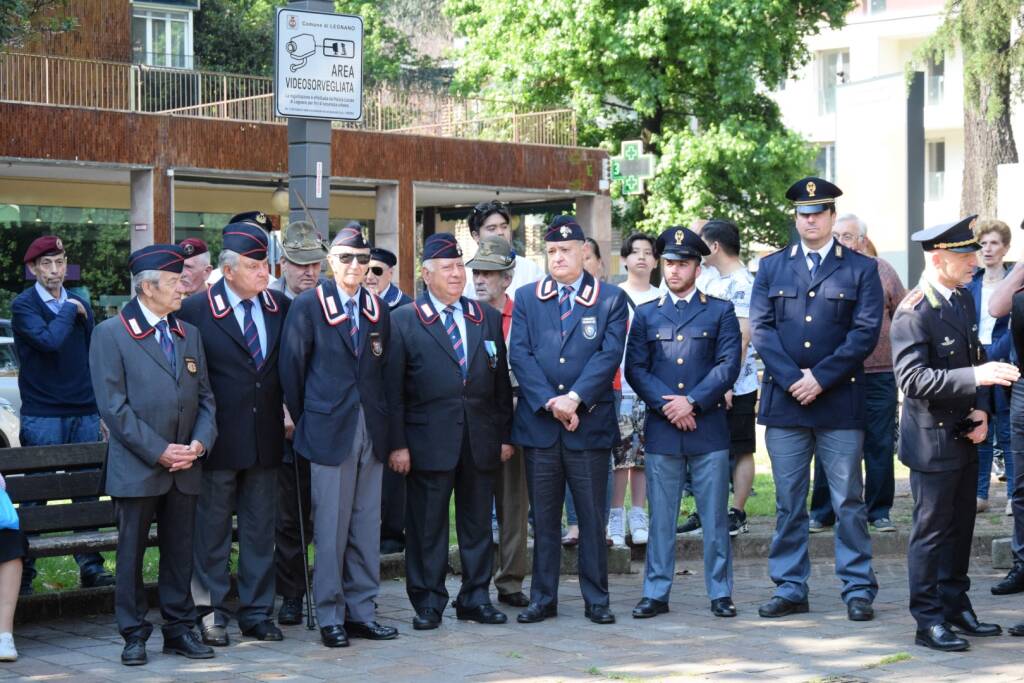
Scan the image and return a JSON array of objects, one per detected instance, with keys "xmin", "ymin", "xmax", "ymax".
[{"xmin": 751, "ymin": 177, "xmax": 883, "ymax": 622}]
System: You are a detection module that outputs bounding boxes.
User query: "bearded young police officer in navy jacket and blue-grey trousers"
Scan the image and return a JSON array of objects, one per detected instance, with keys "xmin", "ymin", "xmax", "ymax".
[{"xmin": 626, "ymin": 227, "xmax": 740, "ymax": 618}]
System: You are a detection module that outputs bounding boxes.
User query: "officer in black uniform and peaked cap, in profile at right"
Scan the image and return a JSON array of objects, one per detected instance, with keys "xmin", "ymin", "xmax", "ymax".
[{"xmin": 892, "ymin": 216, "xmax": 1020, "ymax": 651}]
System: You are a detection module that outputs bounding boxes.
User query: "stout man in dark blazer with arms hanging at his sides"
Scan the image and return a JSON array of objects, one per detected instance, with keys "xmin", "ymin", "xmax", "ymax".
[{"xmin": 387, "ymin": 232, "xmax": 513, "ymax": 630}]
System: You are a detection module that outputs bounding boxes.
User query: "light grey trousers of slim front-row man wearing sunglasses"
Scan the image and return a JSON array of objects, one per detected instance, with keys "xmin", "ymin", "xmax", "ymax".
[{"xmin": 309, "ymin": 415, "xmax": 384, "ymax": 629}]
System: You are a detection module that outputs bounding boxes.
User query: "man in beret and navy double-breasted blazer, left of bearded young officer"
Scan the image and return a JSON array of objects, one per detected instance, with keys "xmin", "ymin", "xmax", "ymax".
[{"xmin": 509, "ymin": 216, "xmax": 628, "ymax": 624}]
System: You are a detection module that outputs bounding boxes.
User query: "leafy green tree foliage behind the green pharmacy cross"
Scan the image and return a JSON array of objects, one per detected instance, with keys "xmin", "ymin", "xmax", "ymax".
[{"xmin": 445, "ymin": 0, "xmax": 854, "ymax": 243}]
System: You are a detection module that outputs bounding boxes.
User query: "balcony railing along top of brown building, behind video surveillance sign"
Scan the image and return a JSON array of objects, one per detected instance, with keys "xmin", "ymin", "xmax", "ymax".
[{"xmin": 0, "ymin": 52, "xmax": 577, "ymax": 146}]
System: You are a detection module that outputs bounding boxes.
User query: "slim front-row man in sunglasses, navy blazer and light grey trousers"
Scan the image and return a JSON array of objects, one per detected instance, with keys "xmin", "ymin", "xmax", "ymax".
[{"xmin": 281, "ymin": 227, "xmax": 398, "ymax": 647}]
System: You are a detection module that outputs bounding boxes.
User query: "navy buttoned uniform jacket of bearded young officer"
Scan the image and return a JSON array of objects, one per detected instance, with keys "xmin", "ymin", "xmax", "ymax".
[{"xmin": 626, "ymin": 292, "xmax": 740, "ymax": 456}]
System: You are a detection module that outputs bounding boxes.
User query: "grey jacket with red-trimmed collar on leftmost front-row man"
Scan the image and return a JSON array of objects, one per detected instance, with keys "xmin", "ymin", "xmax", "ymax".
[{"xmin": 89, "ymin": 299, "xmax": 217, "ymax": 498}]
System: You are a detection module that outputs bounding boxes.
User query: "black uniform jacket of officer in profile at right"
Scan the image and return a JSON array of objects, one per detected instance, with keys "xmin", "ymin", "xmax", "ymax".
[{"xmin": 892, "ymin": 282, "xmax": 993, "ymax": 472}]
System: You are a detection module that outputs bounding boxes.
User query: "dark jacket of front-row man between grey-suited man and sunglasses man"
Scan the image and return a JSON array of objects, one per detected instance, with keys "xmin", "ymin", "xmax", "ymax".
[{"xmin": 178, "ymin": 280, "xmax": 290, "ymax": 470}]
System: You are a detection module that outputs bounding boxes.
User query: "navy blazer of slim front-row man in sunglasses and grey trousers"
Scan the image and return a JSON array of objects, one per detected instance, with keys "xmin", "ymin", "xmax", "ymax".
[{"xmin": 279, "ymin": 282, "xmax": 391, "ymax": 466}]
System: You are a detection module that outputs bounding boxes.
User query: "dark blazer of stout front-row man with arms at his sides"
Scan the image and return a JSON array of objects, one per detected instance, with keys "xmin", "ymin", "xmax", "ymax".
[{"xmin": 387, "ymin": 294, "xmax": 512, "ymax": 471}]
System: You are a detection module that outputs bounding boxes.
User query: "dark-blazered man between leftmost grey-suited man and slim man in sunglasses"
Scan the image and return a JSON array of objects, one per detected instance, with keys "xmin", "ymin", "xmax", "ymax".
[{"xmin": 180, "ymin": 216, "xmax": 289, "ymax": 646}]
